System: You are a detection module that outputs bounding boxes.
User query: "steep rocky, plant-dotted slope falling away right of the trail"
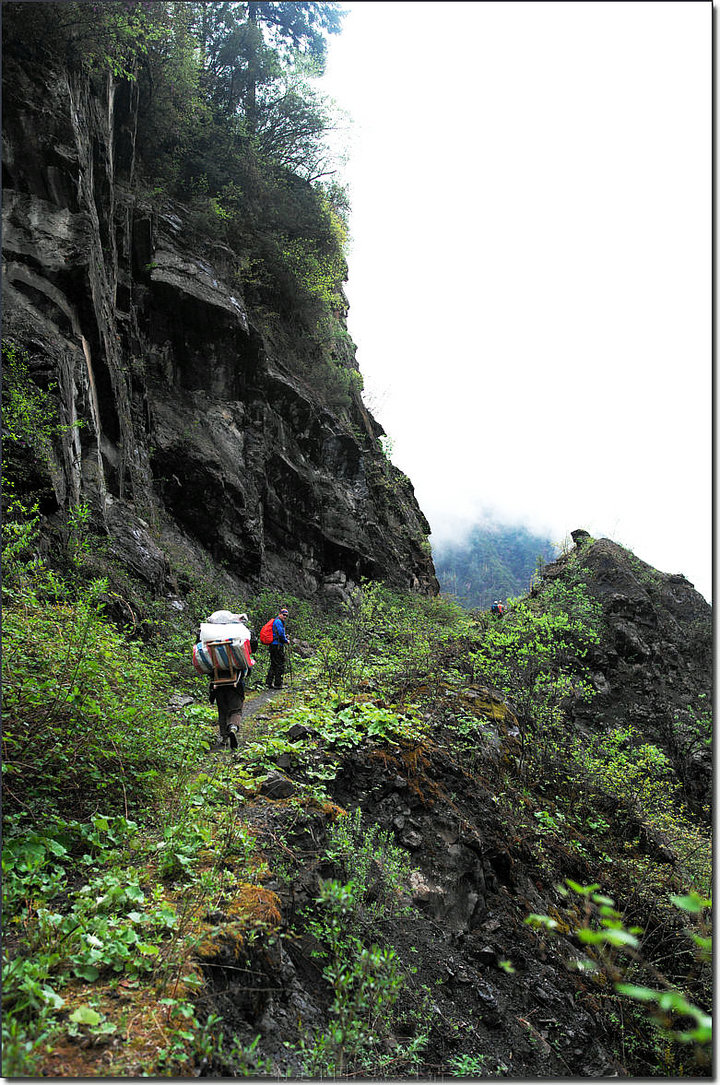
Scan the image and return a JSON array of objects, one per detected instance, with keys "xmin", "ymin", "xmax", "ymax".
[{"xmin": 184, "ymin": 532, "xmax": 711, "ymax": 1078}]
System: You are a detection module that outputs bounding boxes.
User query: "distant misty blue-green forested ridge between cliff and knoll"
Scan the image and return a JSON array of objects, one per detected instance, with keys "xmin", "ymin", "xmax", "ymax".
[{"xmin": 433, "ymin": 524, "xmax": 556, "ymax": 609}]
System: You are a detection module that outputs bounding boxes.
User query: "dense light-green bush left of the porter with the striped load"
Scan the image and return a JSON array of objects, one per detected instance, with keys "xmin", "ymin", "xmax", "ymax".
[{"xmin": 3, "ymin": 577, "xmax": 200, "ymax": 816}]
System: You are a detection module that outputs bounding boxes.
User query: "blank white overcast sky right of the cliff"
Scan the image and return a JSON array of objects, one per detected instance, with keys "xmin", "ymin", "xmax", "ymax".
[{"xmin": 320, "ymin": 0, "xmax": 712, "ymax": 598}]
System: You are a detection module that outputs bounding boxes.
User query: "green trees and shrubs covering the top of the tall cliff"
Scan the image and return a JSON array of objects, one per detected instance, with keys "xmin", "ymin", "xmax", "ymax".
[{"xmin": 3, "ymin": 0, "xmax": 347, "ymax": 331}]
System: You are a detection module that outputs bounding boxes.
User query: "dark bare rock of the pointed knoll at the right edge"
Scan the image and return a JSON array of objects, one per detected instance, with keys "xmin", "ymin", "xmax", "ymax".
[{"xmin": 536, "ymin": 529, "xmax": 712, "ymax": 806}]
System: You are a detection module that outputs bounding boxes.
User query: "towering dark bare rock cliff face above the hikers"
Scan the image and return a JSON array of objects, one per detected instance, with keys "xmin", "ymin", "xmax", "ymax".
[{"xmin": 2, "ymin": 63, "xmax": 437, "ymax": 598}]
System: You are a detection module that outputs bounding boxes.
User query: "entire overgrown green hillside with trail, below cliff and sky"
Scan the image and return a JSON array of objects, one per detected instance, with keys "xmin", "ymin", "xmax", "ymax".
[{"xmin": 3, "ymin": 516, "xmax": 711, "ymax": 1080}]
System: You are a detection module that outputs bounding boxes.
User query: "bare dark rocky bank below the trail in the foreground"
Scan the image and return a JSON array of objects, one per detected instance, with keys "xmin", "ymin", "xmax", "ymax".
[{"xmin": 204, "ymin": 743, "xmax": 623, "ymax": 1080}]
